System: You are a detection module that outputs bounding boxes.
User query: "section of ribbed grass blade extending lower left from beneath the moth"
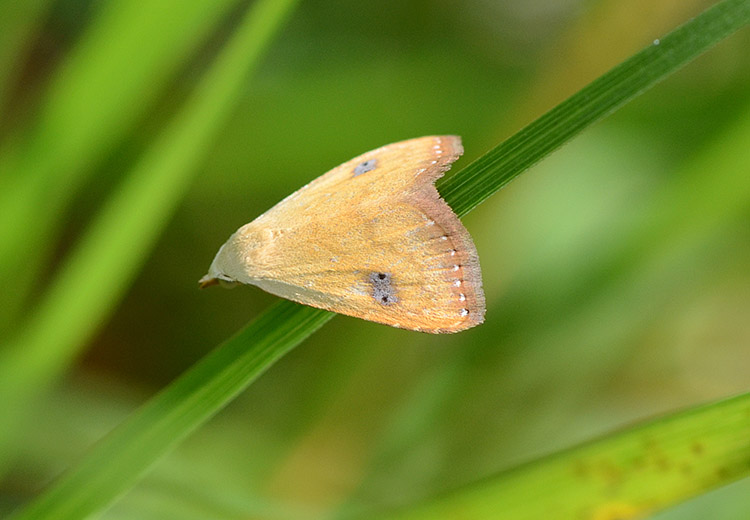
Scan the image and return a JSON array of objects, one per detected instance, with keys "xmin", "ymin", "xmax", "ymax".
[{"xmin": 8, "ymin": 300, "xmax": 333, "ymax": 520}]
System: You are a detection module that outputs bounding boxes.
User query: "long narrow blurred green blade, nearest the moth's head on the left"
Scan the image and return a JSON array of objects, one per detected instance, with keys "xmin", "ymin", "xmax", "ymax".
[{"xmin": 0, "ymin": 0, "xmax": 295, "ymax": 472}]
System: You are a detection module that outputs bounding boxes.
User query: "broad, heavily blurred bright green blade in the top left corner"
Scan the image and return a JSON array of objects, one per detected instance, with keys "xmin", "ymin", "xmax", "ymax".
[{"xmin": 0, "ymin": 0, "xmax": 236, "ymax": 330}]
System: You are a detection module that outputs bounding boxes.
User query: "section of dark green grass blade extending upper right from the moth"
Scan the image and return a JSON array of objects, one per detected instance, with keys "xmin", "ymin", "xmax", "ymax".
[{"xmin": 439, "ymin": 0, "xmax": 750, "ymax": 215}]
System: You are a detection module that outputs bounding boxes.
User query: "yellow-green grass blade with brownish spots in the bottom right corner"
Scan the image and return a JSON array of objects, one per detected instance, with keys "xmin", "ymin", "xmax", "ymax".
[{"xmin": 388, "ymin": 394, "xmax": 750, "ymax": 520}]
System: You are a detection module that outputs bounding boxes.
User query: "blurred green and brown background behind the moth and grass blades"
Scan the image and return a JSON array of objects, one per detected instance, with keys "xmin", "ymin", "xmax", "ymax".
[{"xmin": 0, "ymin": 0, "xmax": 750, "ymax": 519}]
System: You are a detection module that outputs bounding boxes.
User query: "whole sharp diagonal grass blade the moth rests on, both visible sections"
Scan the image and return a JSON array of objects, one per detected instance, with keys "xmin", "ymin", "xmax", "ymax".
[{"xmin": 13, "ymin": 0, "xmax": 750, "ymax": 519}]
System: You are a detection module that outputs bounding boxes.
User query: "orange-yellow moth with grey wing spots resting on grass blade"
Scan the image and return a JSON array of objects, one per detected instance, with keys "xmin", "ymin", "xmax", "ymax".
[{"xmin": 200, "ymin": 136, "xmax": 484, "ymax": 333}]
